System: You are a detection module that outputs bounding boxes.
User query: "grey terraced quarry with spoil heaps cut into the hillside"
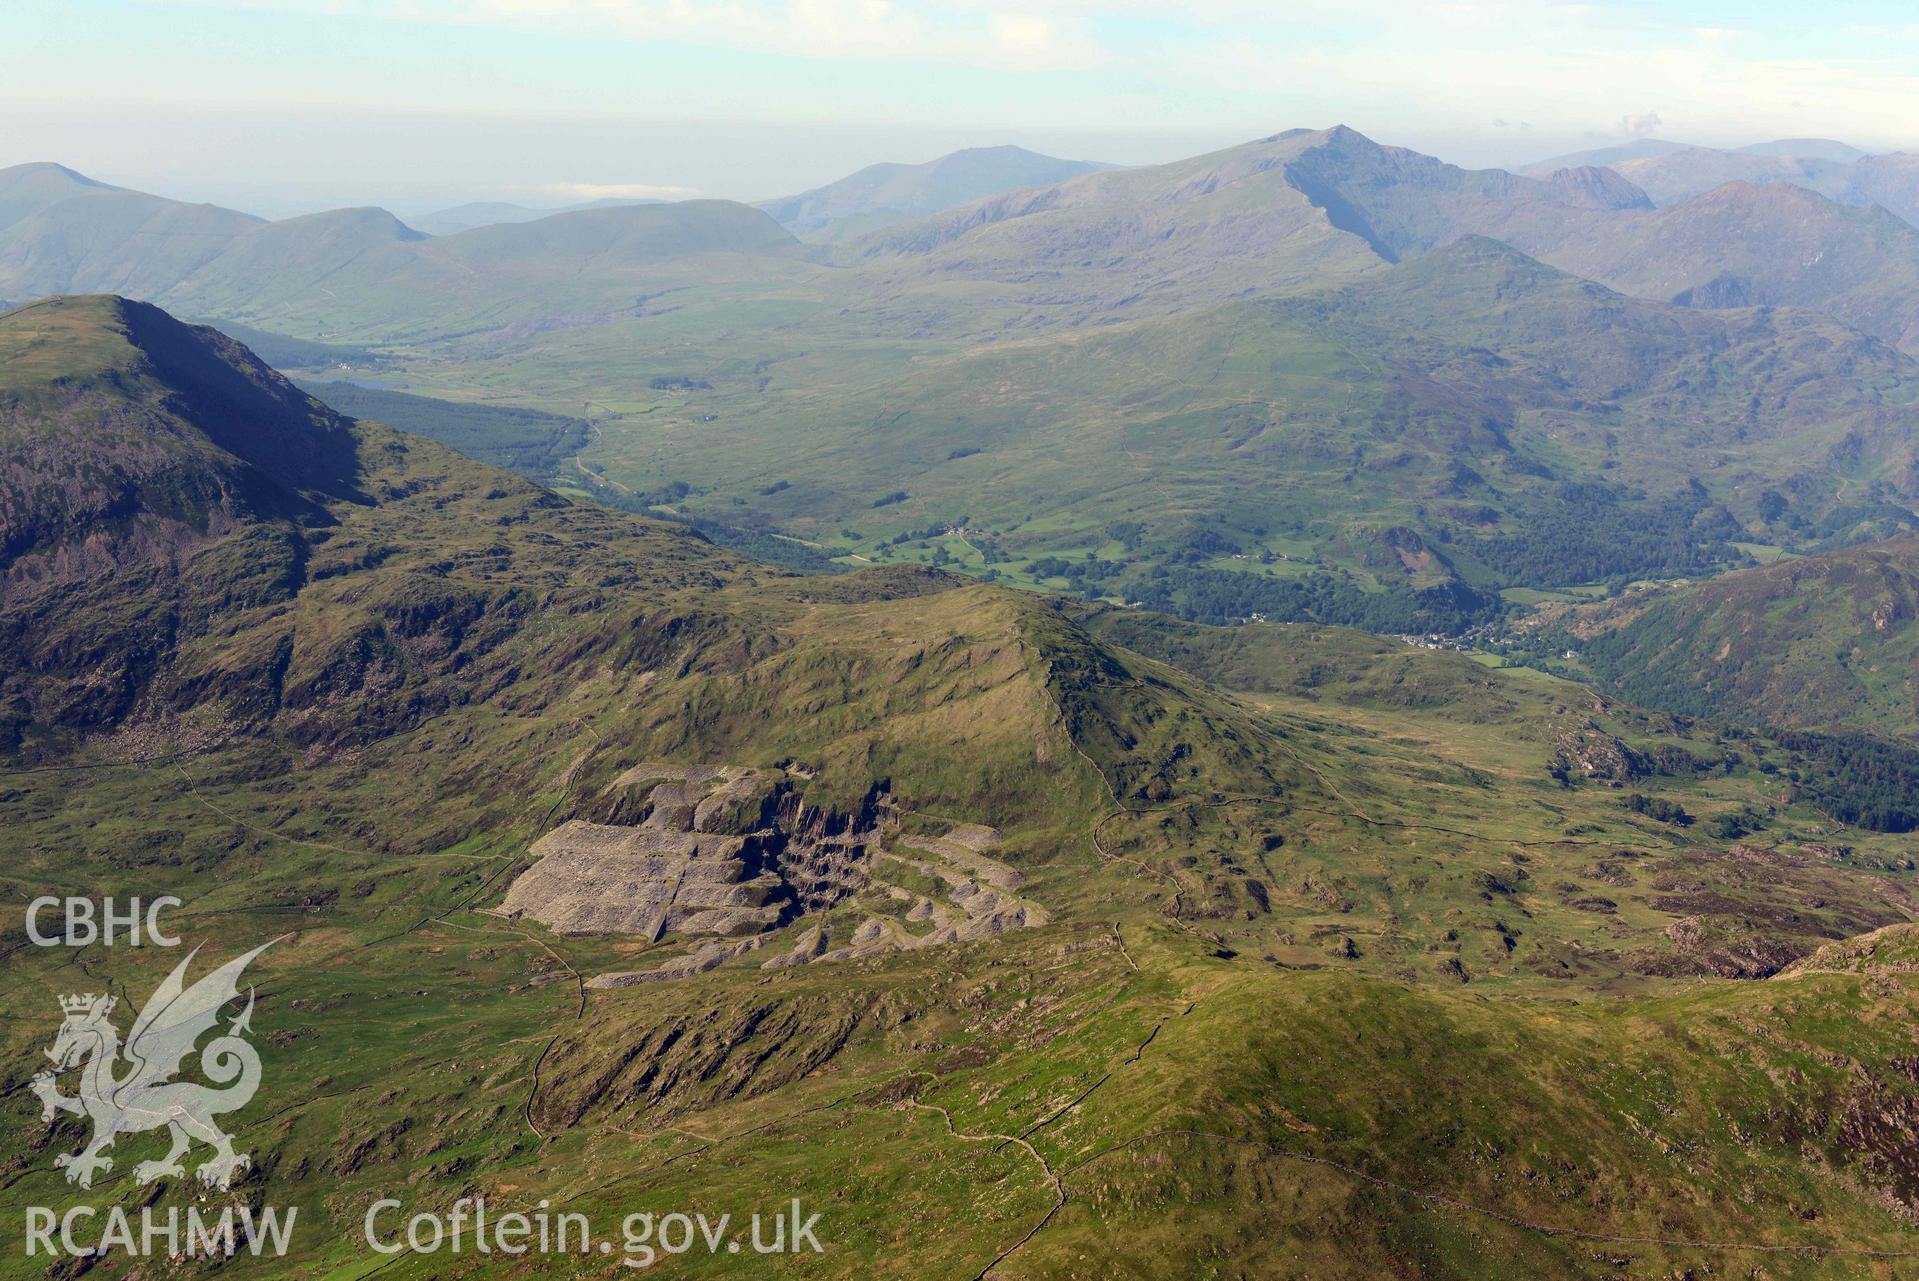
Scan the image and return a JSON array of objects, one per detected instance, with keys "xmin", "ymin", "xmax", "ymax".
[{"xmin": 501, "ymin": 763, "xmax": 1048, "ymax": 988}]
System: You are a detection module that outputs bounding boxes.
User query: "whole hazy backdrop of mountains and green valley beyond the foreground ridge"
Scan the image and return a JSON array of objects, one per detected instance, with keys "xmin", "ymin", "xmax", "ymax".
[{"xmin": 11, "ymin": 127, "xmax": 1919, "ymax": 631}]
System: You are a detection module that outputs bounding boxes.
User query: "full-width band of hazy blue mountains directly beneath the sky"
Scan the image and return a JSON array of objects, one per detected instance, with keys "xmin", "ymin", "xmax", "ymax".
[{"xmin": 14, "ymin": 128, "xmax": 1919, "ymax": 345}]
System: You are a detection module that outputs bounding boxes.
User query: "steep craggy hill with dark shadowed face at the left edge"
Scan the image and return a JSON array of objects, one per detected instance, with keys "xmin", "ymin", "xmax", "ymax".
[{"xmin": 0, "ymin": 297, "xmax": 735, "ymax": 744}]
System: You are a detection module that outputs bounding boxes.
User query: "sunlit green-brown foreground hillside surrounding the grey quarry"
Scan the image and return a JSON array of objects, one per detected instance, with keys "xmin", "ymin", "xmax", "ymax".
[{"xmin": 11, "ymin": 299, "xmax": 1919, "ymax": 1277}]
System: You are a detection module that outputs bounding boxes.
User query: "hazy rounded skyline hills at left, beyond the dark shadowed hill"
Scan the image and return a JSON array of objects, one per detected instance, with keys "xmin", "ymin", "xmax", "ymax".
[{"xmin": 0, "ymin": 165, "xmax": 798, "ymax": 338}]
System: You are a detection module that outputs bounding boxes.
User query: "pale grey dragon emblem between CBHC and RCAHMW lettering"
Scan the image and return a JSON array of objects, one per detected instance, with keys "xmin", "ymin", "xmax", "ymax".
[{"xmin": 31, "ymin": 940, "xmax": 280, "ymax": 1191}]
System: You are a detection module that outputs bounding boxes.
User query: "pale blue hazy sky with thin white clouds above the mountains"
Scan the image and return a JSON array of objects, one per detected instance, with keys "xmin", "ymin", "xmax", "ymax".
[{"xmin": 0, "ymin": 0, "xmax": 1919, "ymax": 217}]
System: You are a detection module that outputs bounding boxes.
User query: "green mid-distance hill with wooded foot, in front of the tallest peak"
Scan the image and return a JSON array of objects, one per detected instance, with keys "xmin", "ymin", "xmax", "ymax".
[{"xmin": 514, "ymin": 240, "xmax": 1919, "ymax": 631}]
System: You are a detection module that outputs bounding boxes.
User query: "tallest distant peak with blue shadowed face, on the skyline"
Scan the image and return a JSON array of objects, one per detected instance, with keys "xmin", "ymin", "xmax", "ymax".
[{"xmin": 846, "ymin": 127, "xmax": 1650, "ymax": 328}]
